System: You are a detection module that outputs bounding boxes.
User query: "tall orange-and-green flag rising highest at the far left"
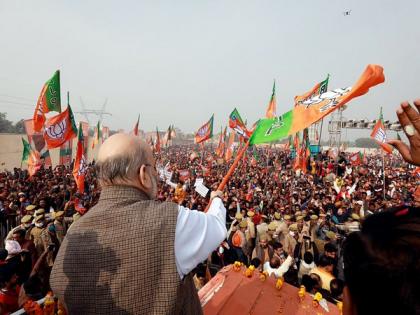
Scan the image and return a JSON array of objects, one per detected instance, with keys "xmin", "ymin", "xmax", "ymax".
[{"xmin": 33, "ymin": 70, "xmax": 61, "ymax": 132}]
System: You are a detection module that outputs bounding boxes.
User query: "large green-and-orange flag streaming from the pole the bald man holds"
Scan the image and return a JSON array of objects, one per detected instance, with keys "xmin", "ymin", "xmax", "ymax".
[{"xmin": 250, "ymin": 65, "xmax": 385, "ymax": 145}]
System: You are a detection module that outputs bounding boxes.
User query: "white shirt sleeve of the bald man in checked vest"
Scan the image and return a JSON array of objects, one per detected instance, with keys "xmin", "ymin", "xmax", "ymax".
[{"xmin": 175, "ymin": 198, "xmax": 227, "ymax": 279}]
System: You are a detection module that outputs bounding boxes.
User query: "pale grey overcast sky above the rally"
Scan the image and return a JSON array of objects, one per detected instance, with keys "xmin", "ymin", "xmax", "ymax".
[{"xmin": 0, "ymin": 0, "xmax": 420, "ymax": 141}]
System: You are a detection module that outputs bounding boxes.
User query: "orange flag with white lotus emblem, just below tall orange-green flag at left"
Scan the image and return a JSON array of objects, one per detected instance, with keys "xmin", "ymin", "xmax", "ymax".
[{"xmin": 44, "ymin": 105, "xmax": 77, "ymax": 149}]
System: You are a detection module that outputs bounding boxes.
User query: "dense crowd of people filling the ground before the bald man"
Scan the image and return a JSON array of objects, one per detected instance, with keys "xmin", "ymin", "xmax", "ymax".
[{"xmin": 0, "ymin": 100, "xmax": 420, "ymax": 314}]
